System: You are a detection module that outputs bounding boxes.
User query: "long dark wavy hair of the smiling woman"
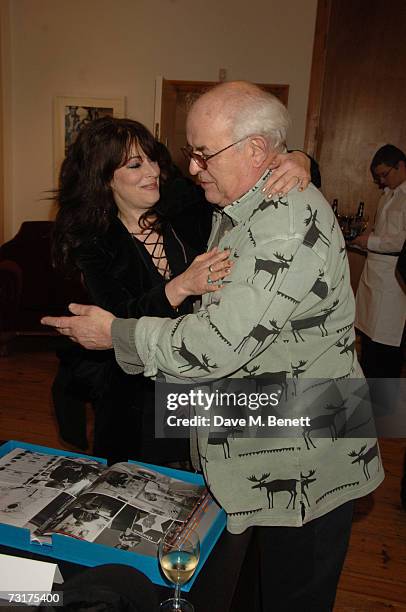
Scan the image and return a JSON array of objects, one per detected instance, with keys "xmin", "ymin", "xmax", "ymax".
[{"xmin": 52, "ymin": 117, "xmax": 170, "ymax": 271}]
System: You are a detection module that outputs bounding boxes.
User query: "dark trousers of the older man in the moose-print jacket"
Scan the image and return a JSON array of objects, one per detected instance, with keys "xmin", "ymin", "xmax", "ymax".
[{"xmin": 254, "ymin": 501, "xmax": 354, "ymax": 612}]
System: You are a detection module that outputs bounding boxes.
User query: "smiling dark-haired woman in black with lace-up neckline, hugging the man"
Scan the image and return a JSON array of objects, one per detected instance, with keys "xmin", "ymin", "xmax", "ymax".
[{"xmin": 53, "ymin": 117, "xmax": 312, "ymax": 463}]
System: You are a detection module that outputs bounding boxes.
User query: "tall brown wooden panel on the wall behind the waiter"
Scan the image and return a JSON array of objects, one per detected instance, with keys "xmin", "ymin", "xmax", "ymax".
[{"xmin": 306, "ymin": 0, "xmax": 406, "ymax": 287}]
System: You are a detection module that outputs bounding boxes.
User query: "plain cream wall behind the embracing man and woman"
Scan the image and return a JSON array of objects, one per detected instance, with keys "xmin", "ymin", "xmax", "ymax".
[{"xmin": 5, "ymin": 0, "xmax": 317, "ymax": 238}]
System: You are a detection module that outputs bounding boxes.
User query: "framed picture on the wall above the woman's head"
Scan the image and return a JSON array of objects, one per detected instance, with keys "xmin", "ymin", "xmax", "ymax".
[{"xmin": 54, "ymin": 96, "xmax": 125, "ymax": 186}]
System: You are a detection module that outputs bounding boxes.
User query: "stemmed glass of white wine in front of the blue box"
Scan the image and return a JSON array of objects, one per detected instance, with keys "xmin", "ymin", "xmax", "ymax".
[{"xmin": 158, "ymin": 528, "xmax": 200, "ymax": 612}]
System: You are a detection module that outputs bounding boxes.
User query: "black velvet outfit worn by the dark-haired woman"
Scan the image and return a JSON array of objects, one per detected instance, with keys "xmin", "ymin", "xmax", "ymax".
[{"xmin": 53, "ymin": 179, "xmax": 211, "ymax": 463}]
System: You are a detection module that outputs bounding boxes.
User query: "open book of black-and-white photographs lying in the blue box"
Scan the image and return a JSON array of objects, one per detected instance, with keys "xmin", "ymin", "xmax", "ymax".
[{"xmin": 0, "ymin": 448, "xmax": 211, "ymax": 557}]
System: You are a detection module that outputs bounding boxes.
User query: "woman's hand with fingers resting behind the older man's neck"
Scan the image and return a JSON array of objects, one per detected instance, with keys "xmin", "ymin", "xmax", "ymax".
[{"xmin": 262, "ymin": 151, "xmax": 311, "ymax": 198}]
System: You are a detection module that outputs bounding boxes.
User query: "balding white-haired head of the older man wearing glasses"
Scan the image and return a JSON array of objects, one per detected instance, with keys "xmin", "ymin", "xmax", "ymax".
[{"xmin": 186, "ymin": 81, "xmax": 289, "ymax": 206}]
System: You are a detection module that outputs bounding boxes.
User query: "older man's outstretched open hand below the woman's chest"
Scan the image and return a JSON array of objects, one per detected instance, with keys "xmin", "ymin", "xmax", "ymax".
[{"xmin": 41, "ymin": 304, "xmax": 115, "ymax": 350}]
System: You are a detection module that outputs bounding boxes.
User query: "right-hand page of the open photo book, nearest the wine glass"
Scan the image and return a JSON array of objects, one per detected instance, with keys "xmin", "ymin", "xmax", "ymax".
[{"xmin": 43, "ymin": 463, "xmax": 205, "ymax": 556}]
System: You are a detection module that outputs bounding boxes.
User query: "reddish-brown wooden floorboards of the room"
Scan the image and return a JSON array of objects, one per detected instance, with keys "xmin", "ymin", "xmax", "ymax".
[{"xmin": 0, "ymin": 338, "xmax": 406, "ymax": 612}]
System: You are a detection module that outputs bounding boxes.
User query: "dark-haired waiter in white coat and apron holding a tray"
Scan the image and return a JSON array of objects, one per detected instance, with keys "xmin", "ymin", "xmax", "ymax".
[{"xmin": 352, "ymin": 144, "xmax": 406, "ymax": 378}]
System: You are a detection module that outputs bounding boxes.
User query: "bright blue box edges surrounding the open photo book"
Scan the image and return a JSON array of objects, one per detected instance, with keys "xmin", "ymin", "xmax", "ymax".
[{"xmin": 0, "ymin": 440, "xmax": 226, "ymax": 591}]
